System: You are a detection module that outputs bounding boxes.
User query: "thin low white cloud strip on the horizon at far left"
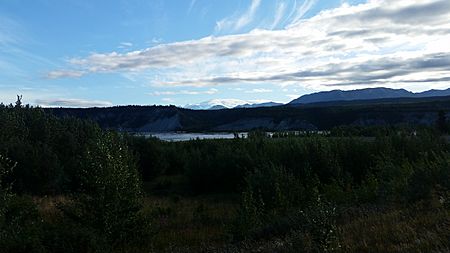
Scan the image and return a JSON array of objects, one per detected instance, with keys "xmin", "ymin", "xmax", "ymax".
[{"xmin": 35, "ymin": 98, "xmax": 112, "ymax": 108}]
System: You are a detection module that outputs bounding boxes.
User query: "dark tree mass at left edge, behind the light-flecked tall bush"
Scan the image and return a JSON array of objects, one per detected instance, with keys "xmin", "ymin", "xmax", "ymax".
[{"xmin": 0, "ymin": 101, "xmax": 101, "ymax": 194}]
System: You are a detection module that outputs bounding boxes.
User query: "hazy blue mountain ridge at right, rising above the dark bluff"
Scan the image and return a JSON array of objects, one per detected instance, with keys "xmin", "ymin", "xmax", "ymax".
[{"xmin": 289, "ymin": 88, "xmax": 450, "ymax": 105}]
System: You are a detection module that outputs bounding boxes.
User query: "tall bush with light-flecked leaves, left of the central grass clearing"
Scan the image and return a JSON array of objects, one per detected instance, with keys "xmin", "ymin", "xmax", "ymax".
[{"xmin": 63, "ymin": 132, "xmax": 149, "ymax": 249}]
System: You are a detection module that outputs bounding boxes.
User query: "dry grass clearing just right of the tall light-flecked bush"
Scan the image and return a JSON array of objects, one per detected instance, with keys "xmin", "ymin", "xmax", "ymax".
[{"xmin": 144, "ymin": 197, "xmax": 237, "ymax": 249}]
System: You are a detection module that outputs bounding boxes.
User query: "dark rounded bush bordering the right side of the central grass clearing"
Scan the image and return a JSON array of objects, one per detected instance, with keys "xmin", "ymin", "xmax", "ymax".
[{"xmin": 232, "ymin": 165, "xmax": 317, "ymax": 239}]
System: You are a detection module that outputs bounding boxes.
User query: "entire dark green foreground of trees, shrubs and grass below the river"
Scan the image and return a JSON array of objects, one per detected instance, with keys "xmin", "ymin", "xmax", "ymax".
[{"xmin": 0, "ymin": 100, "xmax": 450, "ymax": 252}]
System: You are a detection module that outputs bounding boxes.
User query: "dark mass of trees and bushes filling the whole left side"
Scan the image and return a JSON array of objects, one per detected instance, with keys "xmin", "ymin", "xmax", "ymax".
[{"xmin": 0, "ymin": 104, "xmax": 151, "ymax": 252}]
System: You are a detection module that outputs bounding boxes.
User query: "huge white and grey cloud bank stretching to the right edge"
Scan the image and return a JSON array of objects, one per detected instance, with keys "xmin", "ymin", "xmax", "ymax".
[{"xmin": 48, "ymin": 0, "xmax": 450, "ymax": 91}]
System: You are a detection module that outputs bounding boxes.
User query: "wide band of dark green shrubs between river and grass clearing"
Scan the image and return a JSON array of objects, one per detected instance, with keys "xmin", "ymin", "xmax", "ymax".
[{"xmin": 129, "ymin": 129, "xmax": 450, "ymax": 201}]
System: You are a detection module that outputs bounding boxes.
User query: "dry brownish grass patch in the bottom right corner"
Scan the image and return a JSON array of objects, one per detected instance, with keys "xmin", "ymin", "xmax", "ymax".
[{"xmin": 339, "ymin": 203, "xmax": 450, "ymax": 252}]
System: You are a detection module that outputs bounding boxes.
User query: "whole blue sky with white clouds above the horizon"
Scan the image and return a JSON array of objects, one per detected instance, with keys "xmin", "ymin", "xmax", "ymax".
[{"xmin": 0, "ymin": 0, "xmax": 450, "ymax": 107}]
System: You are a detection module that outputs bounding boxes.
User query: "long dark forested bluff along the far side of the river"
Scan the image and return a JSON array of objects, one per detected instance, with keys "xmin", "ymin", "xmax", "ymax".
[{"xmin": 46, "ymin": 97, "xmax": 450, "ymax": 132}]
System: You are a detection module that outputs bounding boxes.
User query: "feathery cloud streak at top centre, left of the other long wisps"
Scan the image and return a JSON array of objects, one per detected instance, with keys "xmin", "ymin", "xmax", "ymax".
[{"xmin": 215, "ymin": 0, "xmax": 261, "ymax": 32}]
